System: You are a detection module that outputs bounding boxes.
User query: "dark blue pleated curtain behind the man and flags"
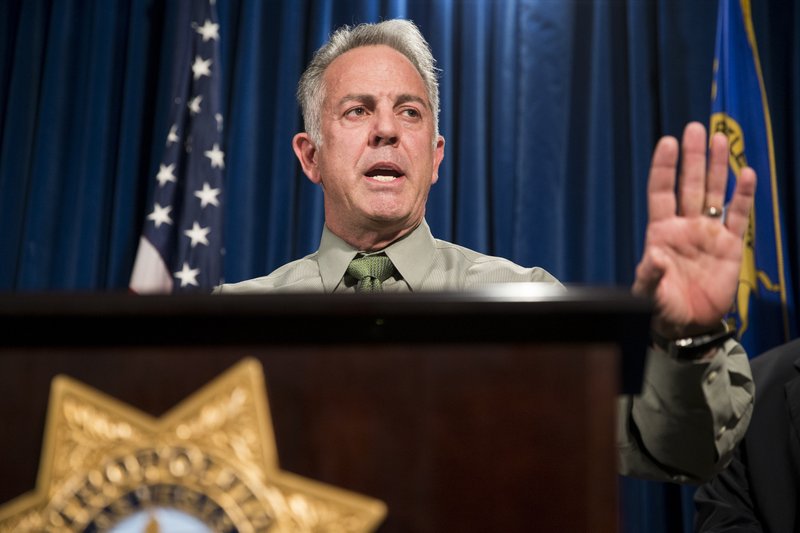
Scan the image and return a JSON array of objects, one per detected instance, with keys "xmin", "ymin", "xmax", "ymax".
[{"xmin": 0, "ymin": 0, "xmax": 800, "ymax": 533}]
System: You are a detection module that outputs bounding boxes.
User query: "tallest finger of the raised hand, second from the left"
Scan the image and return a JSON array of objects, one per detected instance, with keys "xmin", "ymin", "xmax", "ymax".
[{"xmin": 678, "ymin": 122, "xmax": 706, "ymax": 216}]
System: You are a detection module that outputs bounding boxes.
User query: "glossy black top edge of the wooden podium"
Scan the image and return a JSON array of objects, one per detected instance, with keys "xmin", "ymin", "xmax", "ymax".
[{"xmin": 0, "ymin": 283, "xmax": 652, "ymax": 318}]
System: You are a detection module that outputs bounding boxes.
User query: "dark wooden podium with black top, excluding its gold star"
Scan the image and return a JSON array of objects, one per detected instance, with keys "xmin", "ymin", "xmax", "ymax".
[{"xmin": 0, "ymin": 285, "xmax": 651, "ymax": 533}]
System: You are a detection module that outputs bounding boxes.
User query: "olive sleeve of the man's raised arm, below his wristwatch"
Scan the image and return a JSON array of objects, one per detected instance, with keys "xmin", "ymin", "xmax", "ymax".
[{"xmin": 617, "ymin": 340, "xmax": 755, "ymax": 483}]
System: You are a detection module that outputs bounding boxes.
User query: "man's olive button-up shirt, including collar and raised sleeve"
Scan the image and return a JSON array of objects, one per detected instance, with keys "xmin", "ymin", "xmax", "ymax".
[{"xmin": 214, "ymin": 221, "xmax": 754, "ymax": 482}]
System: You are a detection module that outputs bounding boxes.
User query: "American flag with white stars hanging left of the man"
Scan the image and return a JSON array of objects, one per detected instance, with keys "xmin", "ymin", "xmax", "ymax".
[{"xmin": 129, "ymin": 0, "xmax": 225, "ymax": 294}]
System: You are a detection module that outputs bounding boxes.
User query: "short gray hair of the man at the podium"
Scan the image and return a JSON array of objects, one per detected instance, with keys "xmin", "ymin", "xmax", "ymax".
[{"xmin": 297, "ymin": 19, "xmax": 439, "ymax": 145}]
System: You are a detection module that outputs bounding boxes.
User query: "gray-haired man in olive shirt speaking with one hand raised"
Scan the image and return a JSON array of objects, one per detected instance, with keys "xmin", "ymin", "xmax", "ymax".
[{"xmin": 216, "ymin": 20, "xmax": 756, "ymax": 482}]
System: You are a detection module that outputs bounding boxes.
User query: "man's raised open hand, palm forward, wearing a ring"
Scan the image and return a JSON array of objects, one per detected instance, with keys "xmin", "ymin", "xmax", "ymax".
[{"xmin": 633, "ymin": 122, "xmax": 756, "ymax": 339}]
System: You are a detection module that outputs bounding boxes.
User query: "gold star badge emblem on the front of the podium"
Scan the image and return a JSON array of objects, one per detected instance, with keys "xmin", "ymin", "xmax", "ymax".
[{"xmin": 0, "ymin": 358, "xmax": 386, "ymax": 533}]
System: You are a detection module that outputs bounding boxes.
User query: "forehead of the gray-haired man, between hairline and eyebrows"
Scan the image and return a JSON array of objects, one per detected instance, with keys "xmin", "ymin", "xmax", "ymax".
[{"xmin": 325, "ymin": 45, "xmax": 428, "ymax": 102}]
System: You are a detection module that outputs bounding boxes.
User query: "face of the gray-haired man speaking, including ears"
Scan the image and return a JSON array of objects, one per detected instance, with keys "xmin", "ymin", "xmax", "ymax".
[{"xmin": 295, "ymin": 46, "xmax": 444, "ymax": 247}]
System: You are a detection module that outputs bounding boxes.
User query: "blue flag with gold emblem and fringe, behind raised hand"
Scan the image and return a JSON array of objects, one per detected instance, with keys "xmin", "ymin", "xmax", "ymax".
[{"xmin": 709, "ymin": 0, "xmax": 794, "ymax": 357}]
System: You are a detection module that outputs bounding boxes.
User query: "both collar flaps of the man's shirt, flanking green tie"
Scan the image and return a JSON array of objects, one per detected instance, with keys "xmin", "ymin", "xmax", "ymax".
[{"xmin": 318, "ymin": 219, "xmax": 436, "ymax": 293}]
